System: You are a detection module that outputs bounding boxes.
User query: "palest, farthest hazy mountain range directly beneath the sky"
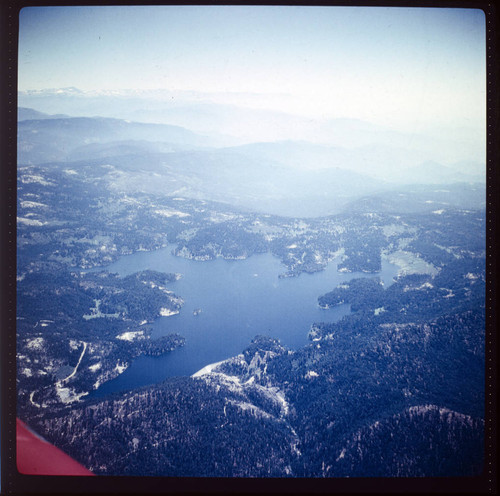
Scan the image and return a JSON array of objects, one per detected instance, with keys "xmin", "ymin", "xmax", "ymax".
[{"xmin": 18, "ymin": 88, "xmax": 486, "ymax": 167}]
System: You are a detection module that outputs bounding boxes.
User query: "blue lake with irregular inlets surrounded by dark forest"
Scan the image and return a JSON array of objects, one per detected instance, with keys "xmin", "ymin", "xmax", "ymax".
[{"xmin": 90, "ymin": 247, "xmax": 397, "ymax": 397}]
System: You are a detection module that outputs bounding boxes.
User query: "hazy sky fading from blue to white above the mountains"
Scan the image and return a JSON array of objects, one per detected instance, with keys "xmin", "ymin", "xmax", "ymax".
[{"xmin": 19, "ymin": 6, "xmax": 486, "ymax": 128}]
